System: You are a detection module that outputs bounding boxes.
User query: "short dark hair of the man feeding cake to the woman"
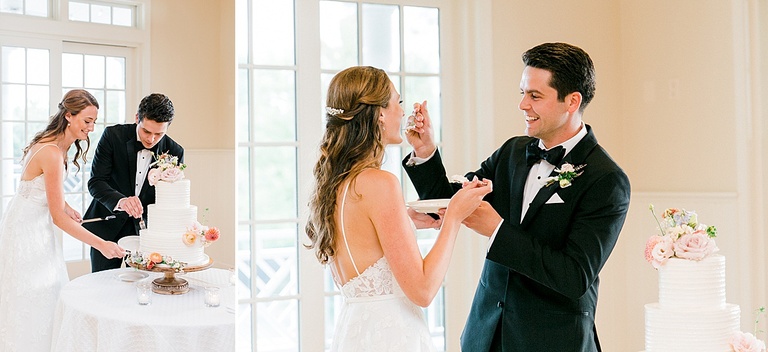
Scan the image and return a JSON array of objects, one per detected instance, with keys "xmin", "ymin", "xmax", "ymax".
[{"xmin": 523, "ymin": 43, "xmax": 595, "ymax": 111}]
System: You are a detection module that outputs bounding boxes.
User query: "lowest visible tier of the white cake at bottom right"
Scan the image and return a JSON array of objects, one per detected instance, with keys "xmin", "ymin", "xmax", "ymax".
[{"xmin": 645, "ymin": 303, "xmax": 741, "ymax": 352}]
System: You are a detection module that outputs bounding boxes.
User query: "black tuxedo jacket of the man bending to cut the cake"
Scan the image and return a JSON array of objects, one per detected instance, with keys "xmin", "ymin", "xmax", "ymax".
[{"xmin": 83, "ymin": 123, "xmax": 184, "ymax": 241}]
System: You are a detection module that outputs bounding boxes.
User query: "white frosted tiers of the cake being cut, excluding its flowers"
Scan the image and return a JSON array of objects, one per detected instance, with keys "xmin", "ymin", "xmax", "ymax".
[{"xmin": 139, "ymin": 179, "xmax": 209, "ymax": 266}]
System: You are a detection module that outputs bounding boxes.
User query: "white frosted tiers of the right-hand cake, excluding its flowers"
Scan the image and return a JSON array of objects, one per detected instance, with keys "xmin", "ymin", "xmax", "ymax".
[{"xmin": 645, "ymin": 254, "xmax": 741, "ymax": 352}]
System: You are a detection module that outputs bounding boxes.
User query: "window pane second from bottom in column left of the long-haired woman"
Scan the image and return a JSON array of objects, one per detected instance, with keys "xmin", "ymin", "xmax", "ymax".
[{"xmin": 254, "ymin": 223, "xmax": 299, "ymax": 297}]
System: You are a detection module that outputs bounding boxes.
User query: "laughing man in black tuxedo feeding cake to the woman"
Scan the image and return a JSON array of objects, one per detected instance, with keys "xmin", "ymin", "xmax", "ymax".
[{"xmin": 403, "ymin": 43, "xmax": 630, "ymax": 352}]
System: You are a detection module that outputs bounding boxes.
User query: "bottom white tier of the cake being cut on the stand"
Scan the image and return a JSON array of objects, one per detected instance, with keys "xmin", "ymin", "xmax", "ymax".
[{"xmin": 139, "ymin": 229, "xmax": 208, "ymax": 266}]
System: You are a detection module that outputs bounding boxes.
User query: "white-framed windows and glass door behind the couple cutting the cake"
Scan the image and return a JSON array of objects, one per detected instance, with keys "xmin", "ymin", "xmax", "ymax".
[{"xmin": 0, "ymin": 0, "xmax": 148, "ymax": 261}]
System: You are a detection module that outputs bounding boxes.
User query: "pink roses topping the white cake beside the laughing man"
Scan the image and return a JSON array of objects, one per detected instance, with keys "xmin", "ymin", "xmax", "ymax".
[{"xmin": 645, "ymin": 204, "xmax": 719, "ymax": 269}]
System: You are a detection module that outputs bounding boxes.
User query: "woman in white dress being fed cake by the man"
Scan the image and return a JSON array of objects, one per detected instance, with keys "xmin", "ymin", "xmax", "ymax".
[{"xmin": 306, "ymin": 67, "xmax": 491, "ymax": 352}]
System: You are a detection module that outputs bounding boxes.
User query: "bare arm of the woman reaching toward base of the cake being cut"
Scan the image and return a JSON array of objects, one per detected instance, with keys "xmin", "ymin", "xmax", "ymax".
[{"xmin": 36, "ymin": 148, "xmax": 125, "ymax": 258}]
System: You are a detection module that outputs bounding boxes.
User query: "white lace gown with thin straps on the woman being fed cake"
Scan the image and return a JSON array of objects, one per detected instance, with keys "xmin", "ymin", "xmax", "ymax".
[{"xmin": 331, "ymin": 184, "xmax": 436, "ymax": 352}]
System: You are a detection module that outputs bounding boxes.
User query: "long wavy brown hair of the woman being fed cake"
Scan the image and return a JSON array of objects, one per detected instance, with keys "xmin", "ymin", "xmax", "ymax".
[{"xmin": 305, "ymin": 66, "xmax": 392, "ymax": 264}]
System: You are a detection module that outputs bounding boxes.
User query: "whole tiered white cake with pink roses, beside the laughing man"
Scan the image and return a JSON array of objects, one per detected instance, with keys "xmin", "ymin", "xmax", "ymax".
[{"xmin": 645, "ymin": 206, "xmax": 765, "ymax": 352}]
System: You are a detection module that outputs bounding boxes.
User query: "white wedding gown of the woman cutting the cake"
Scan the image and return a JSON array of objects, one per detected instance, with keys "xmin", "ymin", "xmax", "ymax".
[{"xmin": 0, "ymin": 144, "xmax": 69, "ymax": 352}]
